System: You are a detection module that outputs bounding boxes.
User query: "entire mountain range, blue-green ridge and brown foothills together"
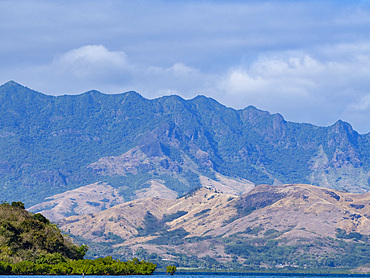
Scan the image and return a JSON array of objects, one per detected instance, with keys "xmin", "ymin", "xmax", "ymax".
[{"xmin": 0, "ymin": 81, "xmax": 370, "ymax": 272}]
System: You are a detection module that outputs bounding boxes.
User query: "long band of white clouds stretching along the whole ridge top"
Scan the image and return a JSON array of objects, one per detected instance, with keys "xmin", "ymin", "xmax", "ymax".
[{"xmin": 3, "ymin": 42, "xmax": 370, "ymax": 132}]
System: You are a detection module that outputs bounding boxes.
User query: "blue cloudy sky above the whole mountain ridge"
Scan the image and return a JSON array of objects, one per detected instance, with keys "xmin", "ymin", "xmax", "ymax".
[{"xmin": 0, "ymin": 0, "xmax": 370, "ymax": 134}]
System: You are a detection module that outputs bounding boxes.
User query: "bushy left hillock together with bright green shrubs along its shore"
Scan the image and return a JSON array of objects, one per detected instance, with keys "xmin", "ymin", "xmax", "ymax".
[{"xmin": 0, "ymin": 202, "xmax": 156, "ymax": 275}]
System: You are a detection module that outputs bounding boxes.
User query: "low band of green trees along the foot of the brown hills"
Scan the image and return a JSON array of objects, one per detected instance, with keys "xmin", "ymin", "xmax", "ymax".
[{"xmin": 71, "ymin": 229, "xmax": 370, "ymax": 273}]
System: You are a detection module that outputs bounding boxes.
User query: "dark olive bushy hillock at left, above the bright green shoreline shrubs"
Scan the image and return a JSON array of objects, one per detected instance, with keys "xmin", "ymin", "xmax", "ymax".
[{"xmin": 0, "ymin": 202, "xmax": 87, "ymax": 263}]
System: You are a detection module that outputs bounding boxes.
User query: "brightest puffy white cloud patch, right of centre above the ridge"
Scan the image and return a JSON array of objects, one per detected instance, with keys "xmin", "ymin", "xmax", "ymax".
[{"xmin": 219, "ymin": 54, "xmax": 324, "ymax": 103}]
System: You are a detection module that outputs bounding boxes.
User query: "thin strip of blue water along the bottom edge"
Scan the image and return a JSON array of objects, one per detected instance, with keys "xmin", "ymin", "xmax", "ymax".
[{"xmin": 0, "ymin": 272, "xmax": 370, "ymax": 278}]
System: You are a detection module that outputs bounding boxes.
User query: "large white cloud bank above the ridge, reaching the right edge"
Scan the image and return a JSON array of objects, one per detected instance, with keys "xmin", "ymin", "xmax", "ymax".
[{"xmin": 212, "ymin": 42, "xmax": 370, "ymax": 132}]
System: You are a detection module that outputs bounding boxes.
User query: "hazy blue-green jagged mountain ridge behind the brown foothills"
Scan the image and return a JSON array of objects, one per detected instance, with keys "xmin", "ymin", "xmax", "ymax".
[{"xmin": 0, "ymin": 82, "xmax": 370, "ymax": 206}]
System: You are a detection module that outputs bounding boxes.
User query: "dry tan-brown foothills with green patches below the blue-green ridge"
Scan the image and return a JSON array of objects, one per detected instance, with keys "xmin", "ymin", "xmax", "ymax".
[{"xmin": 61, "ymin": 184, "xmax": 370, "ymax": 267}]
